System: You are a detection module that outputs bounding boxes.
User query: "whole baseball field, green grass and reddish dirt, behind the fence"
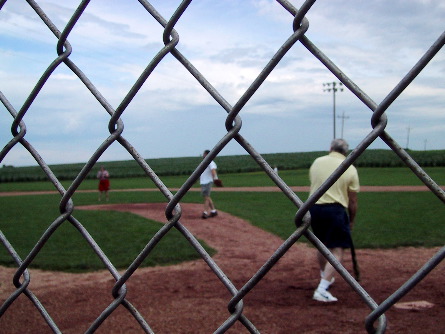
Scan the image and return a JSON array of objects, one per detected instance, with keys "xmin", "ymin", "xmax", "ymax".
[{"xmin": 0, "ymin": 168, "xmax": 445, "ymax": 333}]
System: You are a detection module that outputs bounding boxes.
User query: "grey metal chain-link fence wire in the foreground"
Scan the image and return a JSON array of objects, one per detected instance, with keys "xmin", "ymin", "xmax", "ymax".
[{"xmin": 0, "ymin": 0, "xmax": 445, "ymax": 333}]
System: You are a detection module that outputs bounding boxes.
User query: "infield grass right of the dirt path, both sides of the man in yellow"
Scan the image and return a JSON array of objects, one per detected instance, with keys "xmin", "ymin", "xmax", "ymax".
[{"xmin": 208, "ymin": 192, "xmax": 445, "ymax": 248}]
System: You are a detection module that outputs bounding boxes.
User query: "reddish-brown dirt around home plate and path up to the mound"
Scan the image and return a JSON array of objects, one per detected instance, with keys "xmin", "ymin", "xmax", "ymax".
[{"xmin": 0, "ymin": 200, "xmax": 445, "ymax": 334}]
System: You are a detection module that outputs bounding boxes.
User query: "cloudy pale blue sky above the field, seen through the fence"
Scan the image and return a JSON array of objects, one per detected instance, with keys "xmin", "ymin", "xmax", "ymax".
[{"xmin": 0, "ymin": 0, "xmax": 445, "ymax": 166}]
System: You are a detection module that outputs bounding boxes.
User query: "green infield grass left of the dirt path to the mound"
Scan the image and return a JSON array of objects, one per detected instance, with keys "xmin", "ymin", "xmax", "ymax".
[{"xmin": 0, "ymin": 195, "xmax": 215, "ymax": 272}]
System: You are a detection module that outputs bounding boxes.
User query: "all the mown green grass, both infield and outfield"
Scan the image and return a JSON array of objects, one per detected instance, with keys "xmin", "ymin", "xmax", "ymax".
[{"xmin": 0, "ymin": 167, "xmax": 445, "ymax": 272}]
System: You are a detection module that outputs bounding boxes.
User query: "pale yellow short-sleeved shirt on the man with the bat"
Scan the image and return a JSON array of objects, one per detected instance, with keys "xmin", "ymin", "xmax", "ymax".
[{"xmin": 309, "ymin": 152, "xmax": 360, "ymax": 208}]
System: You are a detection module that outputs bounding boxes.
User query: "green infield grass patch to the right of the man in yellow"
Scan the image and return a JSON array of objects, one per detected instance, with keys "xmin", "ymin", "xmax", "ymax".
[{"xmin": 353, "ymin": 192, "xmax": 445, "ymax": 248}]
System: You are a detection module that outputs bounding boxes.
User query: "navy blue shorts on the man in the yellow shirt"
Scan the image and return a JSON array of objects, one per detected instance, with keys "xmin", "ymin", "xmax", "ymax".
[{"xmin": 309, "ymin": 203, "xmax": 351, "ymax": 248}]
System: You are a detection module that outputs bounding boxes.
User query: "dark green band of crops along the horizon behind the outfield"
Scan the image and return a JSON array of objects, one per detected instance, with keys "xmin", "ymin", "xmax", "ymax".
[{"xmin": 0, "ymin": 150, "xmax": 445, "ymax": 182}]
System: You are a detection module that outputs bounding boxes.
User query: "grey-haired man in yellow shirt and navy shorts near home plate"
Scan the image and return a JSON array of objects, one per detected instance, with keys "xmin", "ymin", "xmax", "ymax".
[{"xmin": 309, "ymin": 139, "xmax": 360, "ymax": 302}]
